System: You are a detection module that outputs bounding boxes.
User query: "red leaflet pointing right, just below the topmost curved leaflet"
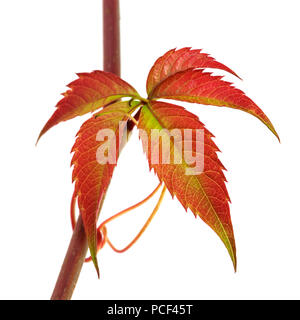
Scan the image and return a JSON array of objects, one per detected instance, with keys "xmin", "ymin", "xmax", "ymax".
[{"xmin": 150, "ymin": 70, "xmax": 279, "ymax": 140}]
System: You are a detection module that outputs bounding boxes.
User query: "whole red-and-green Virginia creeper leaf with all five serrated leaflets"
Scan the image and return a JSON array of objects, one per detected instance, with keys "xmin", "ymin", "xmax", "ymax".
[{"xmin": 38, "ymin": 48, "xmax": 279, "ymax": 275}]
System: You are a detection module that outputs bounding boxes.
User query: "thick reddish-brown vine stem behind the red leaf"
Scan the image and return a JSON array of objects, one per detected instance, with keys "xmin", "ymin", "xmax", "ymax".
[{"xmin": 51, "ymin": 0, "xmax": 121, "ymax": 300}]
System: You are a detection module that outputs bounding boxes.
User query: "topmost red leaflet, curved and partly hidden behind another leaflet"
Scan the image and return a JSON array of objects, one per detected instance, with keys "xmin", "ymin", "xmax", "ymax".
[{"xmin": 147, "ymin": 48, "xmax": 239, "ymax": 96}]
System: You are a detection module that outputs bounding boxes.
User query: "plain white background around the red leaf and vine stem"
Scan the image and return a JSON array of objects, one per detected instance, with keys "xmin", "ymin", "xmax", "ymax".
[{"xmin": 0, "ymin": 0, "xmax": 300, "ymax": 299}]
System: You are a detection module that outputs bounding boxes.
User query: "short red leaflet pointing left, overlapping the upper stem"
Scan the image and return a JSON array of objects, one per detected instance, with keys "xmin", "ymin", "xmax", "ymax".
[{"xmin": 38, "ymin": 71, "xmax": 139, "ymax": 140}]
